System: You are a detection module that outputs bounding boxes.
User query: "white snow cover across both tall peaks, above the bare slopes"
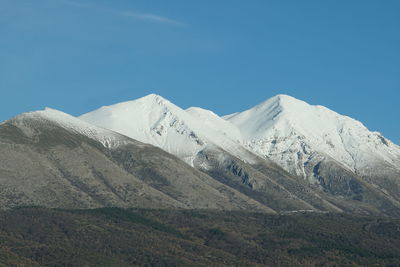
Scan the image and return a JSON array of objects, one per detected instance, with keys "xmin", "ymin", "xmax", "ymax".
[{"xmin": 79, "ymin": 94, "xmax": 400, "ymax": 183}]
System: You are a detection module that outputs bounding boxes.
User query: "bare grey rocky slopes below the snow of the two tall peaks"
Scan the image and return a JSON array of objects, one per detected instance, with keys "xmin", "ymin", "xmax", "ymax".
[{"xmin": 194, "ymin": 147, "xmax": 400, "ymax": 216}]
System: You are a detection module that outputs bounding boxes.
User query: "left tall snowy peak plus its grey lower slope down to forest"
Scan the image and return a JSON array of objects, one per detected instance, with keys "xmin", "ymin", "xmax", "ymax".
[{"xmin": 79, "ymin": 94, "xmax": 356, "ymax": 215}]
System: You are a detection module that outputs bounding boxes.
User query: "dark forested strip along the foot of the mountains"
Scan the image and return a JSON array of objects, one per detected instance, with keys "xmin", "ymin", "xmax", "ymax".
[{"xmin": 0, "ymin": 207, "xmax": 400, "ymax": 267}]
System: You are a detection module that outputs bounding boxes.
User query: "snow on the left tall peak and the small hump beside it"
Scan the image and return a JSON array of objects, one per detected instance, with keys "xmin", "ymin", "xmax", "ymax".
[{"xmin": 79, "ymin": 94, "xmax": 254, "ymax": 166}]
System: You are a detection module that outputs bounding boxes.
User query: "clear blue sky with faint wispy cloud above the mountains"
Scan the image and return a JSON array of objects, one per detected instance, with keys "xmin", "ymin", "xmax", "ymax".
[{"xmin": 0, "ymin": 0, "xmax": 400, "ymax": 144}]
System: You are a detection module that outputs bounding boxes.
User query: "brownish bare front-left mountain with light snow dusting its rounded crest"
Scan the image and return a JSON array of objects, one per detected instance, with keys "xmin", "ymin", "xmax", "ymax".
[{"xmin": 0, "ymin": 109, "xmax": 274, "ymax": 212}]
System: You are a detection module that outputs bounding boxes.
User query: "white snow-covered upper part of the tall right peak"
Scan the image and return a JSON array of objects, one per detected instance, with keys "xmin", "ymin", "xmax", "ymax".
[{"xmin": 224, "ymin": 95, "xmax": 400, "ymax": 180}]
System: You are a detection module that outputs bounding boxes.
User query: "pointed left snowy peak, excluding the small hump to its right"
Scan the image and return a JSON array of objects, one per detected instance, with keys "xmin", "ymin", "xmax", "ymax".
[{"xmin": 80, "ymin": 94, "xmax": 216, "ymax": 163}]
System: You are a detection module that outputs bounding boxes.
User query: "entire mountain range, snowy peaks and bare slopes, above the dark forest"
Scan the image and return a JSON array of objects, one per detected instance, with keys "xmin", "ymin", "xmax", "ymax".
[{"xmin": 0, "ymin": 94, "xmax": 400, "ymax": 216}]
